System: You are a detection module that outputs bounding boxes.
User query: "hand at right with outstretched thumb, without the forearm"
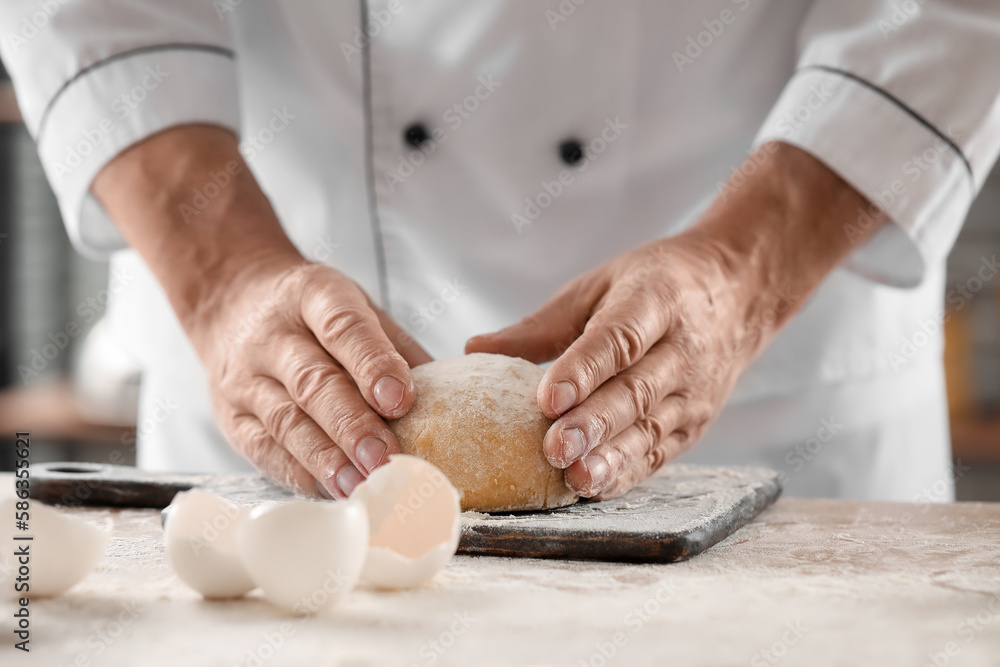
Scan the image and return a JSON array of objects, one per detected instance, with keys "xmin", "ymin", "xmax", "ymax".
[{"xmin": 466, "ymin": 235, "xmax": 762, "ymax": 499}]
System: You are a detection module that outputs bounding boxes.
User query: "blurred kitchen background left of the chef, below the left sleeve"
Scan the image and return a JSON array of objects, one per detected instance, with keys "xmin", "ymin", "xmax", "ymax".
[{"xmin": 0, "ymin": 60, "xmax": 139, "ymax": 470}]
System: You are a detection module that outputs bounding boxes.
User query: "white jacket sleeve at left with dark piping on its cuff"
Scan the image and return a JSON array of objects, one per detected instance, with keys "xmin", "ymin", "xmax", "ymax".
[{"xmin": 0, "ymin": 0, "xmax": 239, "ymax": 257}]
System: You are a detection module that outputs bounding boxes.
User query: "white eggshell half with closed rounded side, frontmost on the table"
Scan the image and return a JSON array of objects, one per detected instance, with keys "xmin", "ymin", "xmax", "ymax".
[{"xmin": 237, "ymin": 500, "xmax": 368, "ymax": 614}]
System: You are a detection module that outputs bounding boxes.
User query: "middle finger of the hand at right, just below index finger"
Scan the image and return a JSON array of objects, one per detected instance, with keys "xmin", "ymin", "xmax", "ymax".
[{"xmin": 542, "ymin": 341, "xmax": 682, "ymax": 468}]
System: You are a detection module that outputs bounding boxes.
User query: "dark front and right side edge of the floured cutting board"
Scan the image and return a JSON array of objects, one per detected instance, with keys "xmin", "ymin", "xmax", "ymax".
[{"xmin": 458, "ymin": 479, "xmax": 781, "ymax": 563}]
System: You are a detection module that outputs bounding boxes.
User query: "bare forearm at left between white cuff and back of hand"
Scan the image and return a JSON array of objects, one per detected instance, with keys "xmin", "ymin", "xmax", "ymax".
[{"xmin": 93, "ymin": 125, "xmax": 305, "ymax": 333}]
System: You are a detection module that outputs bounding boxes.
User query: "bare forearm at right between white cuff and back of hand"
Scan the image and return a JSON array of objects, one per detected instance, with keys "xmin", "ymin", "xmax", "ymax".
[{"xmin": 686, "ymin": 143, "xmax": 886, "ymax": 347}]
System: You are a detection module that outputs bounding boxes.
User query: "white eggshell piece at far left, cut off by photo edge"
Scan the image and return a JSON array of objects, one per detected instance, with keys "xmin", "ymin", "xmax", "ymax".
[{"xmin": 0, "ymin": 497, "xmax": 111, "ymax": 597}]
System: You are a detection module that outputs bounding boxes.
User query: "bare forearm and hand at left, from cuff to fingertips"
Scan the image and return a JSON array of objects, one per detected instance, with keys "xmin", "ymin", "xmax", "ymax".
[{"xmin": 92, "ymin": 125, "xmax": 430, "ymax": 498}]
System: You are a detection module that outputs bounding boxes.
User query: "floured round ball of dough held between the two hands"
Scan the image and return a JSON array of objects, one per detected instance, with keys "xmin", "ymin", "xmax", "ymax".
[{"xmin": 389, "ymin": 354, "xmax": 578, "ymax": 512}]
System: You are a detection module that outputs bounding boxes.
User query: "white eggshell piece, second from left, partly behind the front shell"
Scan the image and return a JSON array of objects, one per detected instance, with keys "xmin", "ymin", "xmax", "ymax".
[{"xmin": 163, "ymin": 489, "xmax": 256, "ymax": 598}]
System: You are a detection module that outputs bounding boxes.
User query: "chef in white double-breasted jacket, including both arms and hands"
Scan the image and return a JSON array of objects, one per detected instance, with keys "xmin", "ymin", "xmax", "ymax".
[{"xmin": 0, "ymin": 0, "xmax": 1000, "ymax": 500}]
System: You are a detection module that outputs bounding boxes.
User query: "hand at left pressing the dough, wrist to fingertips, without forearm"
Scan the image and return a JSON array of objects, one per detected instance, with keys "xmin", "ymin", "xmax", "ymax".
[{"xmin": 190, "ymin": 253, "xmax": 430, "ymax": 498}]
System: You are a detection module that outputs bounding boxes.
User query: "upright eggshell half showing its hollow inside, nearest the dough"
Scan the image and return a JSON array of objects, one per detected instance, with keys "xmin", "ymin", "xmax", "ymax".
[{"xmin": 351, "ymin": 454, "xmax": 462, "ymax": 588}]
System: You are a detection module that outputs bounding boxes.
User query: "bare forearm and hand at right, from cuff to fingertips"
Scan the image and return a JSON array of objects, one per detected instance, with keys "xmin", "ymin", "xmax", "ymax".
[{"xmin": 466, "ymin": 144, "xmax": 888, "ymax": 499}]
